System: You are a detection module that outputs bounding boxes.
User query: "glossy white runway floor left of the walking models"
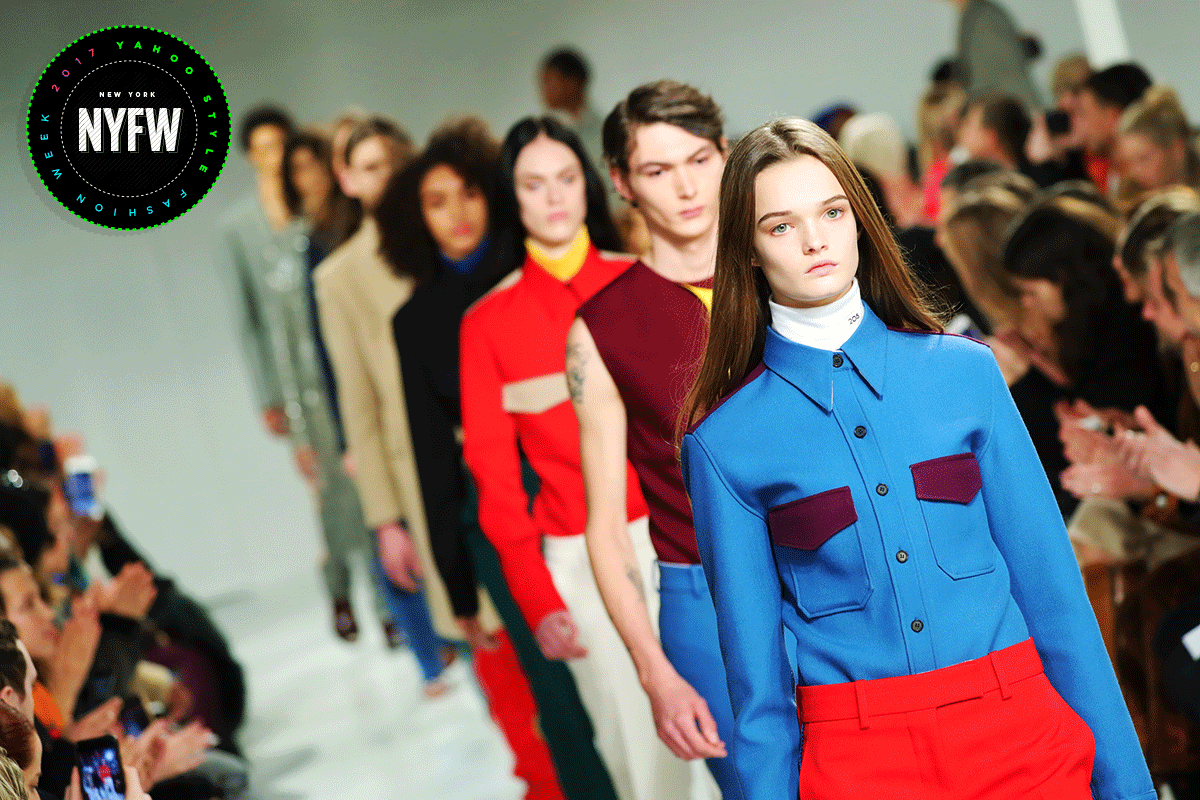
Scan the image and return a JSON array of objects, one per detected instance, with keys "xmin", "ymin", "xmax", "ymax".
[{"xmin": 210, "ymin": 570, "xmax": 524, "ymax": 800}]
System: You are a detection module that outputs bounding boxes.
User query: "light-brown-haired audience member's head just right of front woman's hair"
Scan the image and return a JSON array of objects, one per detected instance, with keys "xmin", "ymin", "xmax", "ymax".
[{"xmin": 943, "ymin": 186, "xmax": 1026, "ymax": 335}]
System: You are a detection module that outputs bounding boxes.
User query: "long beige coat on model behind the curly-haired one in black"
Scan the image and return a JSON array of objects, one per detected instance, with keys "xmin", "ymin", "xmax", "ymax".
[{"xmin": 313, "ymin": 217, "xmax": 500, "ymax": 638}]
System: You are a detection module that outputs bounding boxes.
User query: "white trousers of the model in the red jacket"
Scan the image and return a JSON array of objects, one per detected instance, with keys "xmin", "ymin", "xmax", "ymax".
[{"xmin": 542, "ymin": 517, "xmax": 720, "ymax": 800}]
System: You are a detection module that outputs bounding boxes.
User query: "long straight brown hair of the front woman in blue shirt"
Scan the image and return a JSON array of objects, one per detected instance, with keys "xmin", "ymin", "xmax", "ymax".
[{"xmin": 683, "ymin": 118, "xmax": 942, "ymax": 425}]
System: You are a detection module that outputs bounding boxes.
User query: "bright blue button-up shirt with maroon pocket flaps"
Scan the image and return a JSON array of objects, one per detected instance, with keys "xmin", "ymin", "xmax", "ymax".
[{"xmin": 682, "ymin": 303, "xmax": 1156, "ymax": 800}]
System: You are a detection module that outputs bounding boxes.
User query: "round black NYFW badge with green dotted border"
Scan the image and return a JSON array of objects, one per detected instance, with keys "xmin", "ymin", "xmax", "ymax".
[{"xmin": 26, "ymin": 25, "xmax": 230, "ymax": 230}]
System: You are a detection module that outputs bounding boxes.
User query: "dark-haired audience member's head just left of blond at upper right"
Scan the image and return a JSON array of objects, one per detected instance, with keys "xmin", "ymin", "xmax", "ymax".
[{"xmin": 1070, "ymin": 64, "xmax": 1152, "ymax": 197}]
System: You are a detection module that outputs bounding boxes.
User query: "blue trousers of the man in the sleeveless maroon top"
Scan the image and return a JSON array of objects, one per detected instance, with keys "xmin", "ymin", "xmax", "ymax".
[{"xmin": 659, "ymin": 561, "xmax": 742, "ymax": 800}]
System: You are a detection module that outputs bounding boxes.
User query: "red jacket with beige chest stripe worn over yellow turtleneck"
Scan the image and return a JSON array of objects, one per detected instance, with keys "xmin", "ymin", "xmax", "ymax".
[{"xmin": 460, "ymin": 246, "xmax": 647, "ymax": 630}]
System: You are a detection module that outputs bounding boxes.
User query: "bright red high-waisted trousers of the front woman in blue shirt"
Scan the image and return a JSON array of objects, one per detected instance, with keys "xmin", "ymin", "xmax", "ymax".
[{"xmin": 796, "ymin": 639, "xmax": 1096, "ymax": 800}]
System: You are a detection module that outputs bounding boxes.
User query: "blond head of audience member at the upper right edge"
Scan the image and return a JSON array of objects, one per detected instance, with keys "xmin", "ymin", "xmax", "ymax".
[{"xmin": 1115, "ymin": 86, "xmax": 1200, "ymax": 203}]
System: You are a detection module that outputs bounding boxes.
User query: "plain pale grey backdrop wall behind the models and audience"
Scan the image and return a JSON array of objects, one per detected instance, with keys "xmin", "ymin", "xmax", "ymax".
[{"xmin": 0, "ymin": 0, "xmax": 1200, "ymax": 596}]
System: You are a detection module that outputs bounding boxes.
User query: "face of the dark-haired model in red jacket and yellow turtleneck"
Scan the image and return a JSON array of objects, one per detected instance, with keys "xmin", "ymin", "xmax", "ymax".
[{"xmin": 512, "ymin": 133, "xmax": 588, "ymax": 252}]
